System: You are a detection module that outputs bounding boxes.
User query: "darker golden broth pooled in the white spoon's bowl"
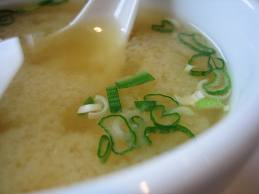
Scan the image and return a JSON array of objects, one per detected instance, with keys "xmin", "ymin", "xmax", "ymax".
[{"xmin": 28, "ymin": 22, "xmax": 126, "ymax": 77}]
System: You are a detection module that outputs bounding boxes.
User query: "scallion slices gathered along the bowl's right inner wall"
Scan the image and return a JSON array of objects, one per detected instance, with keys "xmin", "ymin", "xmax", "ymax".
[{"xmin": 178, "ymin": 27, "xmax": 231, "ymax": 109}]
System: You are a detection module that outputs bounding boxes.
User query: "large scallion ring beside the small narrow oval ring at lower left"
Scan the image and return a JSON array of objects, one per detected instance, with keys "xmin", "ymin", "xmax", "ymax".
[{"xmin": 98, "ymin": 115, "xmax": 136, "ymax": 155}]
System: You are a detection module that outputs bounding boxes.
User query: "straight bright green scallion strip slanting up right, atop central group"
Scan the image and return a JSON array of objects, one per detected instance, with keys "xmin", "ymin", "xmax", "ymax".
[{"xmin": 116, "ymin": 71, "xmax": 155, "ymax": 89}]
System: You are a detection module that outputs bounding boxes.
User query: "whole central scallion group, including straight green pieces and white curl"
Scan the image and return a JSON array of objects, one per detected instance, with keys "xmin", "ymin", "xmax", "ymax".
[{"xmin": 78, "ymin": 71, "xmax": 194, "ymax": 162}]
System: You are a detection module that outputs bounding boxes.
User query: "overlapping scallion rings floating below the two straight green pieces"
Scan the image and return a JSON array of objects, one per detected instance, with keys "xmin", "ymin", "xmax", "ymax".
[{"xmin": 97, "ymin": 91, "xmax": 194, "ymax": 162}]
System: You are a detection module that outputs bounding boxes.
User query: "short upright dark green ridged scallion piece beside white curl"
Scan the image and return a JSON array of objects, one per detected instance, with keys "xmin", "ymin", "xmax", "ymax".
[{"xmin": 106, "ymin": 86, "xmax": 121, "ymax": 113}]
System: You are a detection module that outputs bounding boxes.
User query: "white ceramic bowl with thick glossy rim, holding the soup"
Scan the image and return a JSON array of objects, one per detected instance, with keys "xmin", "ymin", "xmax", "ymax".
[{"xmin": 1, "ymin": 0, "xmax": 259, "ymax": 194}]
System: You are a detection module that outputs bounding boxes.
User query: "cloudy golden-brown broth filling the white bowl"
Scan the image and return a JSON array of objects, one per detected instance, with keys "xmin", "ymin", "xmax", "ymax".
[{"xmin": 0, "ymin": 2, "xmax": 230, "ymax": 194}]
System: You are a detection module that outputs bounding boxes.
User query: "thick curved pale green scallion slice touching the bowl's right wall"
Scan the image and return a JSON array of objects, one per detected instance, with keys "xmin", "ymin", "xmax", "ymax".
[{"xmin": 202, "ymin": 69, "xmax": 231, "ymax": 95}]
